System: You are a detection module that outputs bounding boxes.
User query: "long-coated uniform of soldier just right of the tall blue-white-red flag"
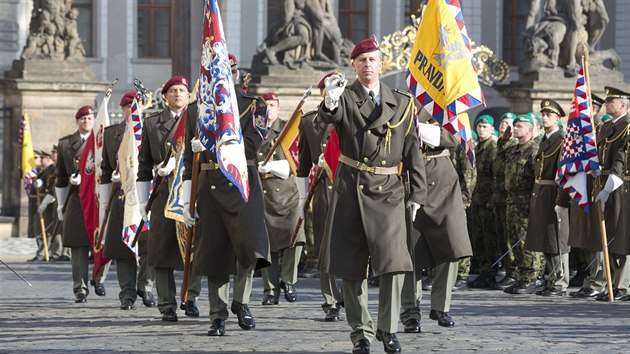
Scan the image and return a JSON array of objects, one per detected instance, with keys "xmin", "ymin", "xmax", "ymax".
[{"xmin": 258, "ymin": 119, "xmax": 306, "ymax": 302}]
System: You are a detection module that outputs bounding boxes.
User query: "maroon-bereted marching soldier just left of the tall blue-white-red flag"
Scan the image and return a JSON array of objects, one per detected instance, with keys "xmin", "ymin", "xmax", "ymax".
[{"xmin": 136, "ymin": 76, "xmax": 201, "ymax": 322}]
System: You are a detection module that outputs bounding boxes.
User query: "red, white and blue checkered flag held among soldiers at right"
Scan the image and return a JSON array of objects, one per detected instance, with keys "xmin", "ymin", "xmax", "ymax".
[{"xmin": 556, "ymin": 59, "xmax": 600, "ymax": 213}]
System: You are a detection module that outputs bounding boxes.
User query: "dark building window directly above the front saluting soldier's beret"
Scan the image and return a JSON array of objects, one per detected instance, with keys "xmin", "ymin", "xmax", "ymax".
[{"xmin": 339, "ymin": 0, "xmax": 370, "ymax": 43}]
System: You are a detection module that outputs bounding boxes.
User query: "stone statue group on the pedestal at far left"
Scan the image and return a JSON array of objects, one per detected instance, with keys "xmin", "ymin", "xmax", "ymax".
[{"xmin": 22, "ymin": 0, "xmax": 85, "ymax": 61}]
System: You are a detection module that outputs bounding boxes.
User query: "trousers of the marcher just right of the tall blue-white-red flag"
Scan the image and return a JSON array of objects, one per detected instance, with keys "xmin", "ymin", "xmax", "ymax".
[{"xmin": 261, "ymin": 245, "xmax": 304, "ymax": 297}]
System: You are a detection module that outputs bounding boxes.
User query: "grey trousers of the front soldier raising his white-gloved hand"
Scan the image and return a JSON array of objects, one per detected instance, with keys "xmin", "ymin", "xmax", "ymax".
[{"xmin": 343, "ymin": 272, "xmax": 405, "ymax": 343}]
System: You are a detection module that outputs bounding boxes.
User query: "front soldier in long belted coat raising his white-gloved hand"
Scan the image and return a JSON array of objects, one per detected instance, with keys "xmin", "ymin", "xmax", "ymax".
[{"xmin": 318, "ymin": 39, "xmax": 428, "ymax": 353}]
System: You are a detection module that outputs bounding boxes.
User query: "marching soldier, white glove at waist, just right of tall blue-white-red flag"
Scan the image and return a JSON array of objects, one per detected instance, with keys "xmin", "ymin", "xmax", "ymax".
[{"xmin": 258, "ymin": 92, "xmax": 306, "ymax": 305}]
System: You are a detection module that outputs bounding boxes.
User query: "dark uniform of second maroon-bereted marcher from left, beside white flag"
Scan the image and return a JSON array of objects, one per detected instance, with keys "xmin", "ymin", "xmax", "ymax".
[{"xmin": 100, "ymin": 121, "xmax": 153, "ymax": 304}]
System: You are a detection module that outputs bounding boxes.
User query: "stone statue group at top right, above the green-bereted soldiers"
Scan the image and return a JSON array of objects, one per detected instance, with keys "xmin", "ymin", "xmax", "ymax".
[{"xmin": 519, "ymin": 0, "xmax": 621, "ymax": 77}]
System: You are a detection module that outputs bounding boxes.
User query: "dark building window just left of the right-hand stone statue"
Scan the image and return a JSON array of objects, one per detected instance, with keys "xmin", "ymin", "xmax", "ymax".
[{"xmin": 503, "ymin": 0, "xmax": 530, "ymax": 65}]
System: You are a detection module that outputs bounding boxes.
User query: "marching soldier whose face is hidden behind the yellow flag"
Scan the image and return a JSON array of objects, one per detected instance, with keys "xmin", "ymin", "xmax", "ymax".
[{"xmin": 400, "ymin": 118, "xmax": 472, "ymax": 333}]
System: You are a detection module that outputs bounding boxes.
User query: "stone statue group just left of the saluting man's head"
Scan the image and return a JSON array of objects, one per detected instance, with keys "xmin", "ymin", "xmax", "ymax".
[{"xmin": 254, "ymin": 0, "xmax": 349, "ymax": 69}]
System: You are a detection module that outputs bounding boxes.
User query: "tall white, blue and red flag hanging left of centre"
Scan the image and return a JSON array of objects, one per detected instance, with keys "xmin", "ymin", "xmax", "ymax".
[{"xmin": 197, "ymin": 0, "xmax": 249, "ymax": 202}]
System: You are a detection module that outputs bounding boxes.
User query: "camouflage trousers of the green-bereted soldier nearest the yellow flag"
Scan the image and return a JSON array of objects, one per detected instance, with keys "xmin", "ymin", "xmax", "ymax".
[{"xmin": 471, "ymin": 205, "xmax": 501, "ymax": 276}]
